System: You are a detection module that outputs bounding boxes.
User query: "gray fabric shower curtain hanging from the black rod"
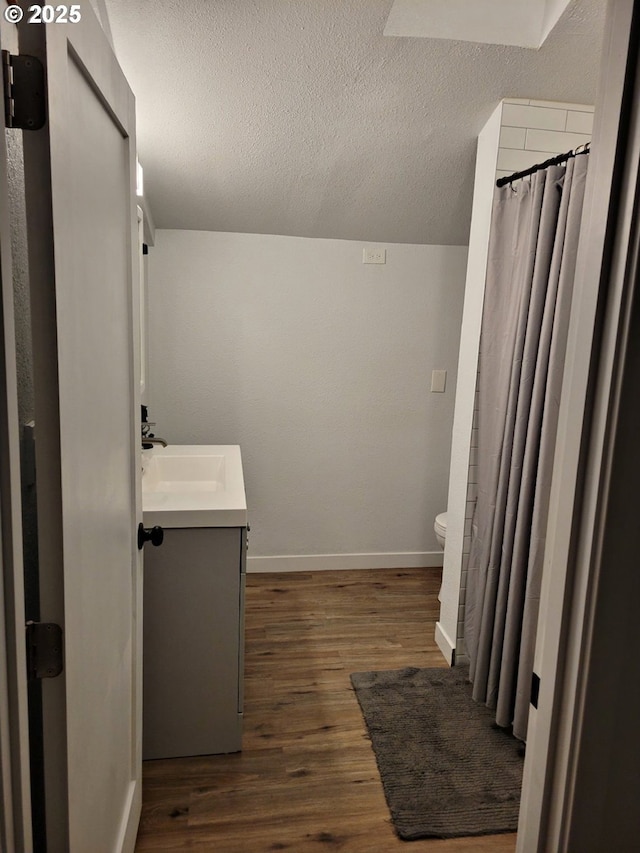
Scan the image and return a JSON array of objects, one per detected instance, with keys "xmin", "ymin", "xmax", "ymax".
[{"xmin": 465, "ymin": 154, "xmax": 589, "ymax": 739}]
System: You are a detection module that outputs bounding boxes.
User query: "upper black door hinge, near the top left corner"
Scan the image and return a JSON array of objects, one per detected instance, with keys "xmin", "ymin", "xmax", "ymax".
[{"xmin": 2, "ymin": 50, "xmax": 47, "ymax": 130}]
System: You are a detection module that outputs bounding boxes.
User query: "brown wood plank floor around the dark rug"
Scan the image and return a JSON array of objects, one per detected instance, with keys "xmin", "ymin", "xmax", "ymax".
[{"xmin": 136, "ymin": 569, "xmax": 515, "ymax": 853}]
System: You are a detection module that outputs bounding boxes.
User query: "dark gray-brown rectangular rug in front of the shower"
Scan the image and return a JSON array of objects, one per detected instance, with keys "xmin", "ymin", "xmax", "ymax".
[{"xmin": 351, "ymin": 666, "xmax": 523, "ymax": 841}]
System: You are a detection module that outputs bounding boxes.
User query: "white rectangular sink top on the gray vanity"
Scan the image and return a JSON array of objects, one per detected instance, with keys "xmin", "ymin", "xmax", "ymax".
[{"xmin": 142, "ymin": 444, "xmax": 247, "ymax": 527}]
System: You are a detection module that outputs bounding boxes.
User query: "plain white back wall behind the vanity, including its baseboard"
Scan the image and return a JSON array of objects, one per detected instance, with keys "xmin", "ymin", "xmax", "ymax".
[{"xmin": 149, "ymin": 230, "xmax": 467, "ymax": 570}]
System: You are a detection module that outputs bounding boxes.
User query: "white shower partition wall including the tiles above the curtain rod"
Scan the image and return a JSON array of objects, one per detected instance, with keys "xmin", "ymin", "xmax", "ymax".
[{"xmin": 436, "ymin": 98, "xmax": 594, "ymax": 661}]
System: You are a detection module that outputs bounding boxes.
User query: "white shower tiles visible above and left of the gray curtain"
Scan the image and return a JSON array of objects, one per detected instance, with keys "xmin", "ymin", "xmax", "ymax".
[{"xmin": 456, "ymin": 98, "xmax": 594, "ymax": 660}]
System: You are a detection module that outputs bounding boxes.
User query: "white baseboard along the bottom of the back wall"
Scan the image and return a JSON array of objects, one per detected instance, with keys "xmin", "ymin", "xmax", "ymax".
[{"xmin": 247, "ymin": 551, "xmax": 442, "ymax": 572}]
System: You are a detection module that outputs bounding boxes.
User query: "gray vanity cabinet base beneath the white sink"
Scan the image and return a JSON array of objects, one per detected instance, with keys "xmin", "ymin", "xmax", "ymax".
[{"xmin": 142, "ymin": 527, "xmax": 246, "ymax": 759}]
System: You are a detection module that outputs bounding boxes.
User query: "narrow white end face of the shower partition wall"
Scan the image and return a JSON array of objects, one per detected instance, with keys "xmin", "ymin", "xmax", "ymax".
[{"xmin": 436, "ymin": 102, "xmax": 503, "ymax": 654}]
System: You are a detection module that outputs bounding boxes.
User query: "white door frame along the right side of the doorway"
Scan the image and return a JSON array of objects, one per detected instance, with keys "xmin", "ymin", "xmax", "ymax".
[{"xmin": 517, "ymin": 0, "xmax": 640, "ymax": 853}]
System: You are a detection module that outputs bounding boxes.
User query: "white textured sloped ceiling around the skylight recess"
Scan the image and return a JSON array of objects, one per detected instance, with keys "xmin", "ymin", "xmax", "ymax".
[{"xmin": 106, "ymin": 0, "xmax": 606, "ymax": 245}]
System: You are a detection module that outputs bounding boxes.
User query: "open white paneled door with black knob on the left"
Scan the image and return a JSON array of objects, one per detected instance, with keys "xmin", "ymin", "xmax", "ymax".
[{"xmin": 20, "ymin": 2, "xmax": 142, "ymax": 853}]
